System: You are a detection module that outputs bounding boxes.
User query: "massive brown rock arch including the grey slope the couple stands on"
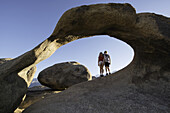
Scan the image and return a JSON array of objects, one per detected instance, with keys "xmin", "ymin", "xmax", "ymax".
[{"xmin": 0, "ymin": 3, "xmax": 170, "ymax": 113}]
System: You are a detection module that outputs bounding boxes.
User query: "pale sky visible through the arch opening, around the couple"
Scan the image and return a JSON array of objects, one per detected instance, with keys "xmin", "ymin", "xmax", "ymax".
[{"xmin": 35, "ymin": 35, "xmax": 134, "ymax": 77}]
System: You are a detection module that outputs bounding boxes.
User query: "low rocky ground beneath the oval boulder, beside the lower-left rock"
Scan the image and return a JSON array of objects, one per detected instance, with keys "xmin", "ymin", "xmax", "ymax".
[{"xmin": 14, "ymin": 86, "xmax": 60, "ymax": 113}]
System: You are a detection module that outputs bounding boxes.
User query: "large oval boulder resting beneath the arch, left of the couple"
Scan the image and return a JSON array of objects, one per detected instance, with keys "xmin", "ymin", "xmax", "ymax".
[{"xmin": 38, "ymin": 62, "xmax": 92, "ymax": 90}]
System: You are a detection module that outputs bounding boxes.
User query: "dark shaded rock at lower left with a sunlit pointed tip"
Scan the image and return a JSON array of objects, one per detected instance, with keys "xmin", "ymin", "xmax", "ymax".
[{"xmin": 0, "ymin": 58, "xmax": 36, "ymax": 113}]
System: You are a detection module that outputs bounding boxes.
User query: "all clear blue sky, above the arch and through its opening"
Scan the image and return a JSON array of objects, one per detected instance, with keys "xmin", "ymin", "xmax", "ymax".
[{"xmin": 0, "ymin": 0, "xmax": 170, "ymax": 77}]
